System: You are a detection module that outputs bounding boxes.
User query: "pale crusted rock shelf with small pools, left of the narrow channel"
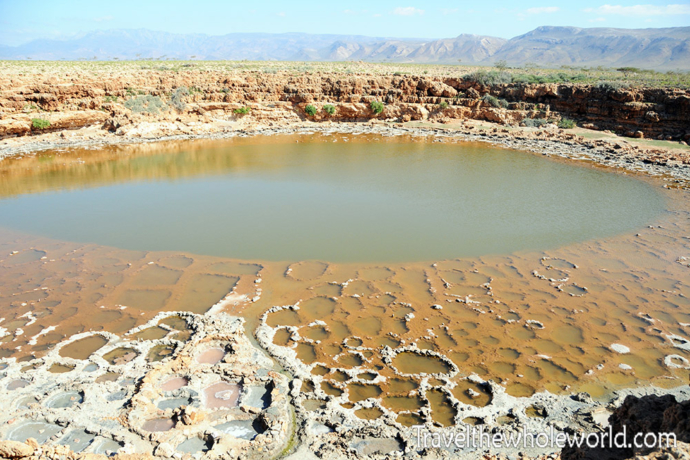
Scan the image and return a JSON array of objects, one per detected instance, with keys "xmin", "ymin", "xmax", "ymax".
[{"xmin": 0, "ymin": 312, "xmax": 294, "ymax": 459}]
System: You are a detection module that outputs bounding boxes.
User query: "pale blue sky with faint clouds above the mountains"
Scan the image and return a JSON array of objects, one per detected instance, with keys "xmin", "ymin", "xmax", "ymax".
[{"xmin": 0, "ymin": 0, "xmax": 690, "ymax": 46}]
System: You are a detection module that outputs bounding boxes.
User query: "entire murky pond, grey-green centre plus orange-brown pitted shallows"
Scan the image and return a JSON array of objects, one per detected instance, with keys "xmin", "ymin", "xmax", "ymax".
[{"xmin": 0, "ymin": 136, "xmax": 690, "ymax": 430}]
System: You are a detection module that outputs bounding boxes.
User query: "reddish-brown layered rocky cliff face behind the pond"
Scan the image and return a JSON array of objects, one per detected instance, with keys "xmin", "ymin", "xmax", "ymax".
[{"xmin": 0, "ymin": 71, "xmax": 690, "ymax": 141}]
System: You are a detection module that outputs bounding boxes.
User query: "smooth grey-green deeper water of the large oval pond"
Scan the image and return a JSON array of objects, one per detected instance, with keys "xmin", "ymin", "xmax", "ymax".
[{"xmin": 0, "ymin": 136, "xmax": 663, "ymax": 262}]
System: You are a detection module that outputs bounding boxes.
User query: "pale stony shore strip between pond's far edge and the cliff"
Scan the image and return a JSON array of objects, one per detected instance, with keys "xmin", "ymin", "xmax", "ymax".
[{"xmin": 0, "ymin": 122, "xmax": 690, "ymax": 189}]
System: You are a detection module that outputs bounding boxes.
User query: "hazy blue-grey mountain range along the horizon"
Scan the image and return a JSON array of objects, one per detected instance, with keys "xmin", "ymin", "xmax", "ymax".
[{"xmin": 0, "ymin": 26, "xmax": 690, "ymax": 70}]
